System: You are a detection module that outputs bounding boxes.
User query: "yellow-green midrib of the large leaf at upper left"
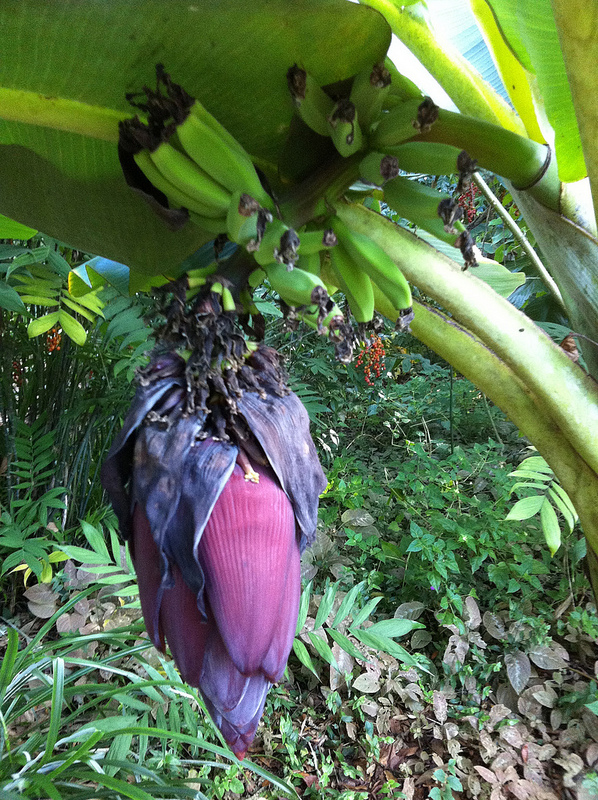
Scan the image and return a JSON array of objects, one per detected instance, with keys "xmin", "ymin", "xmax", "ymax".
[{"xmin": 0, "ymin": 88, "xmax": 126, "ymax": 144}]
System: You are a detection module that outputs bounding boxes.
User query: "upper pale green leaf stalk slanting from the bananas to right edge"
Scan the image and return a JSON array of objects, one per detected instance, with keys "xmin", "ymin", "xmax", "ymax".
[{"xmin": 336, "ymin": 202, "xmax": 598, "ymax": 472}]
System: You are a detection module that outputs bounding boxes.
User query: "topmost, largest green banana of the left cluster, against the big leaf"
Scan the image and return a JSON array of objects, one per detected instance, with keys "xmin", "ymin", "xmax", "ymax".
[{"xmin": 176, "ymin": 101, "xmax": 271, "ymax": 204}]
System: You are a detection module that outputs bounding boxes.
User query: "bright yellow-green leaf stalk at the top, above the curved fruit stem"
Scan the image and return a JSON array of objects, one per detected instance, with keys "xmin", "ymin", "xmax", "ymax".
[{"xmin": 360, "ymin": 0, "xmax": 525, "ymax": 135}]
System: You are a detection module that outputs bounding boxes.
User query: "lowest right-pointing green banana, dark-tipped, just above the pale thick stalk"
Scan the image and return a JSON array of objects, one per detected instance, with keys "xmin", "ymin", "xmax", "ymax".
[{"xmin": 384, "ymin": 176, "xmax": 463, "ymax": 244}]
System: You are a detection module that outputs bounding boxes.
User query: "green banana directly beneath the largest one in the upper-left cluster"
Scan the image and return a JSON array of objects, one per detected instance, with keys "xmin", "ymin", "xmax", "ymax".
[{"xmin": 150, "ymin": 142, "xmax": 230, "ymax": 216}]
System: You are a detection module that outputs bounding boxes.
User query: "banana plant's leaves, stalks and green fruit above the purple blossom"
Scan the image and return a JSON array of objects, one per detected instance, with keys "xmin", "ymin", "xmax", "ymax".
[{"xmin": 0, "ymin": 0, "xmax": 598, "ymax": 591}]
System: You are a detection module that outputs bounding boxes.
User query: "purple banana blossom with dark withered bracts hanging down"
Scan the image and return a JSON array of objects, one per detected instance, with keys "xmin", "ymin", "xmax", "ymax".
[{"xmin": 102, "ymin": 348, "xmax": 326, "ymax": 758}]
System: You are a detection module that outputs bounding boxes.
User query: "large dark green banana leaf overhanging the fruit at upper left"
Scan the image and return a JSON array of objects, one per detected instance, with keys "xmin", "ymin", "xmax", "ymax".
[{"xmin": 0, "ymin": 0, "xmax": 390, "ymax": 274}]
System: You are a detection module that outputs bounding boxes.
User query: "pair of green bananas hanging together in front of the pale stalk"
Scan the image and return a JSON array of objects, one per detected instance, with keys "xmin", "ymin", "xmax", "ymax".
[{"xmin": 330, "ymin": 211, "xmax": 412, "ymax": 328}]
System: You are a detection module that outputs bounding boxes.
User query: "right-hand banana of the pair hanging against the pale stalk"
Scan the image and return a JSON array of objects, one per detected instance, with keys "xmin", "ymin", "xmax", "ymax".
[{"xmin": 331, "ymin": 214, "xmax": 412, "ymax": 311}]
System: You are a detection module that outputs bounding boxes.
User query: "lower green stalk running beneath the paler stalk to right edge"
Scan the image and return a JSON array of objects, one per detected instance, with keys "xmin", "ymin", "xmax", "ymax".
[{"xmin": 411, "ymin": 302, "xmax": 598, "ymax": 597}]
